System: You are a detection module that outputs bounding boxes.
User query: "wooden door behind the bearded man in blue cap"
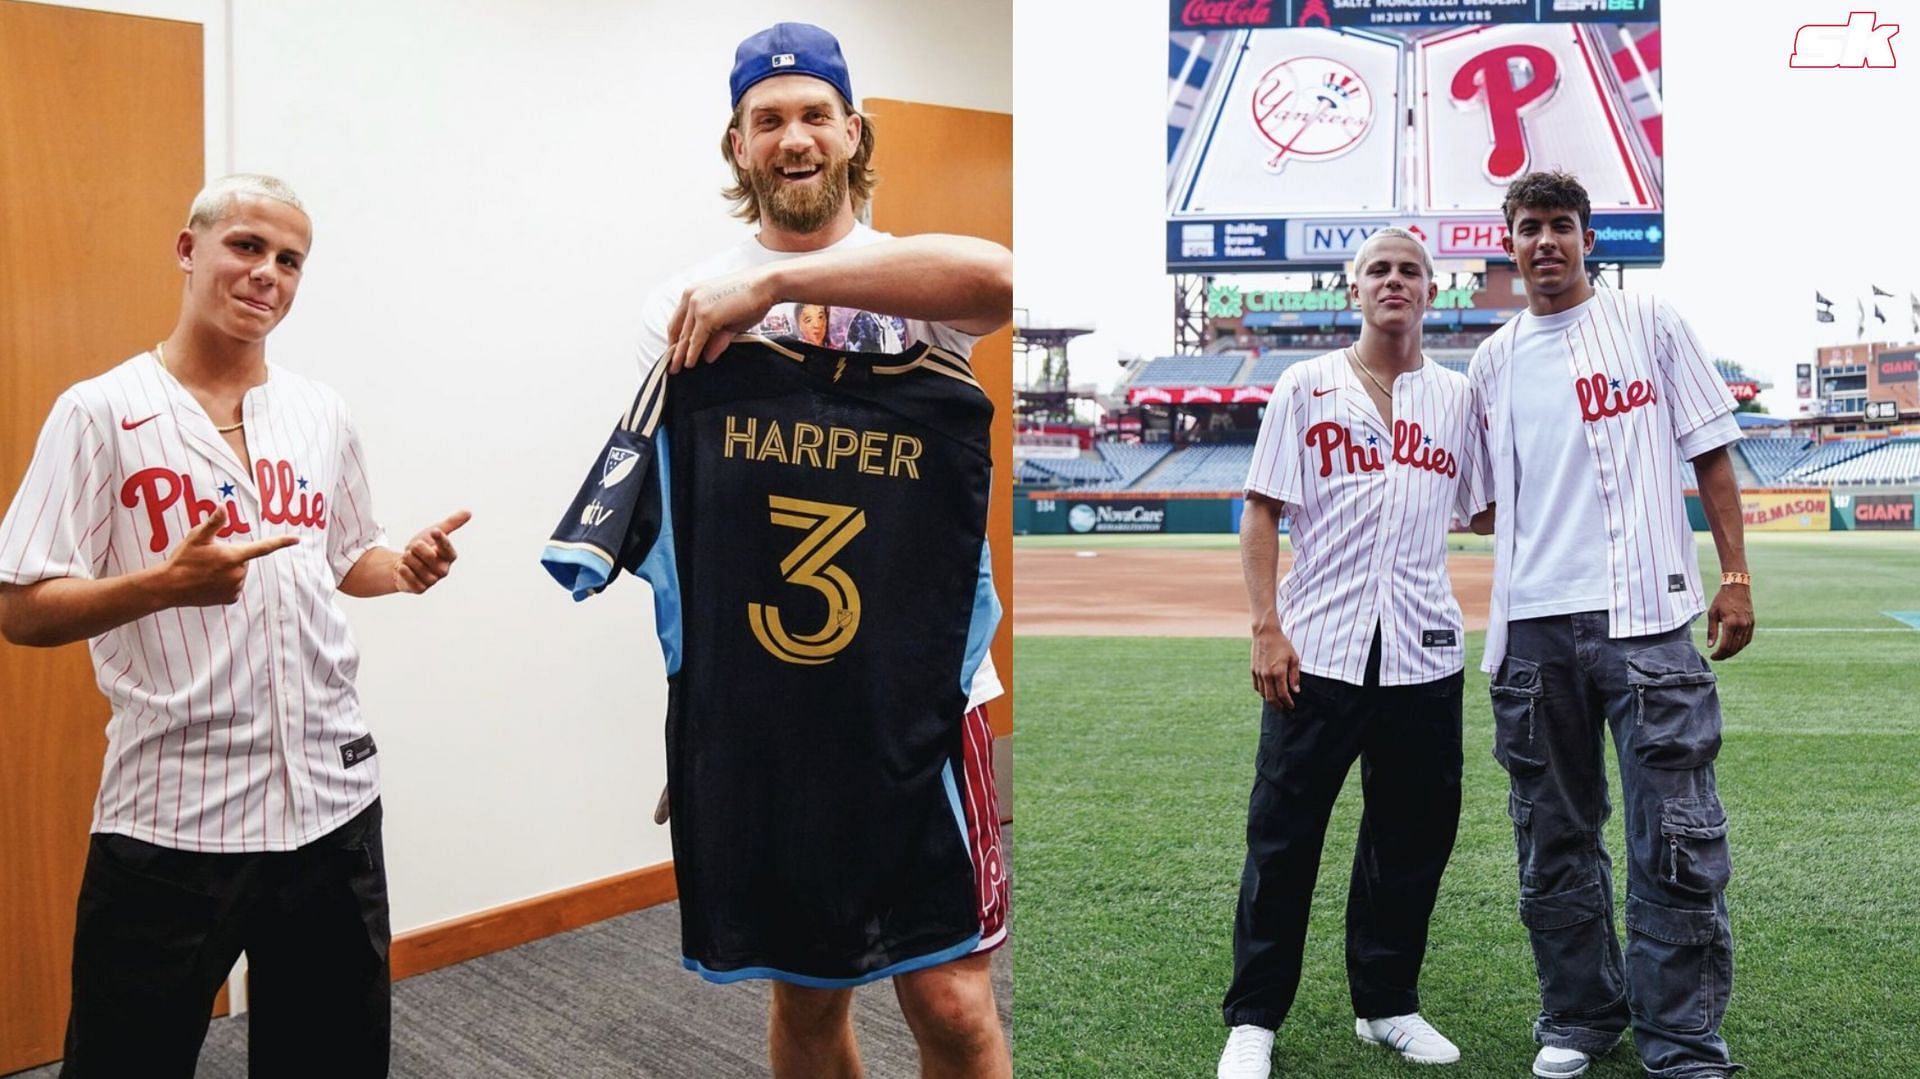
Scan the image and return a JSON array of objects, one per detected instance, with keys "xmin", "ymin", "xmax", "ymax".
[{"xmin": 864, "ymin": 98, "xmax": 1014, "ymax": 816}]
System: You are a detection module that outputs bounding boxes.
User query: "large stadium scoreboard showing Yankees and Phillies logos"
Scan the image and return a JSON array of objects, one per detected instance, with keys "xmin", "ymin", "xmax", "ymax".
[{"xmin": 1167, "ymin": 0, "xmax": 1665, "ymax": 273}]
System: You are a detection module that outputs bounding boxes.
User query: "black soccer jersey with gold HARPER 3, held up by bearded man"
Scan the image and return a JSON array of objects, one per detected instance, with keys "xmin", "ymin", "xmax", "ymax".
[{"xmin": 543, "ymin": 338, "xmax": 1000, "ymax": 987}]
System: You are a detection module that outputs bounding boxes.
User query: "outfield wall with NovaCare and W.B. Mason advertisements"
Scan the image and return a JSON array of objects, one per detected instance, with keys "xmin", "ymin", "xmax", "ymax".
[{"xmin": 1014, "ymin": 488, "xmax": 1916, "ymax": 536}]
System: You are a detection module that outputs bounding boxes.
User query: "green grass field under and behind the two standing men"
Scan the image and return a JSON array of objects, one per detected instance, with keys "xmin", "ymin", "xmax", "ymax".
[{"xmin": 1014, "ymin": 532, "xmax": 1920, "ymax": 1079}]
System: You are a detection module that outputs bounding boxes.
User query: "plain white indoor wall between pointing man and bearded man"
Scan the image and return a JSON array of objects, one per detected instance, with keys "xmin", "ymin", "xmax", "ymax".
[{"xmin": 48, "ymin": 0, "xmax": 1012, "ymax": 931}]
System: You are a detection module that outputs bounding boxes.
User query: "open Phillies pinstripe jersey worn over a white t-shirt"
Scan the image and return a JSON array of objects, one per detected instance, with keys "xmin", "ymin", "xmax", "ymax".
[{"xmin": 1469, "ymin": 288, "xmax": 1740, "ymax": 672}]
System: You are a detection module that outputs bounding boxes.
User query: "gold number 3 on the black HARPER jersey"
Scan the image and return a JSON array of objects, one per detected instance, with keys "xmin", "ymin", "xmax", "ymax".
[{"xmin": 747, "ymin": 495, "xmax": 866, "ymax": 666}]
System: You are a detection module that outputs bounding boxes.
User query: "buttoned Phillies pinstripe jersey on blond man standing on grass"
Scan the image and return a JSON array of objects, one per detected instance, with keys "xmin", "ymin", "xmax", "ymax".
[{"xmin": 1246, "ymin": 349, "xmax": 1484, "ymax": 685}]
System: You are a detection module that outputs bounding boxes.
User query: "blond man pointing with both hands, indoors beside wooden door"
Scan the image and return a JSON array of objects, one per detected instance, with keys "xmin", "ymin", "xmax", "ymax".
[{"xmin": 0, "ymin": 175, "xmax": 468, "ymax": 1079}]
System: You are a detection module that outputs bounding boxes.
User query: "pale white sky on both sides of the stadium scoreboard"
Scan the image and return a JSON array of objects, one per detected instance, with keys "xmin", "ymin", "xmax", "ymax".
[{"xmin": 1014, "ymin": 0, "xmax": 1920, "ymax": 415}]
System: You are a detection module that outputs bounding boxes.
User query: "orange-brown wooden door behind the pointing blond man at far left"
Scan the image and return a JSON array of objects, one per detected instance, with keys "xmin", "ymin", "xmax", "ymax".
[{"xmin": 0, "ymin": 0, "xmax": 204, "ymax": 1075}]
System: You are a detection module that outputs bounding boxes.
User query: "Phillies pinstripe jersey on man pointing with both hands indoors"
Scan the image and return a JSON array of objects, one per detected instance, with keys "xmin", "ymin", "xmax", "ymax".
[{"xmin": 0, "ymin": 353, "xmax": 384, "ymax": 852}]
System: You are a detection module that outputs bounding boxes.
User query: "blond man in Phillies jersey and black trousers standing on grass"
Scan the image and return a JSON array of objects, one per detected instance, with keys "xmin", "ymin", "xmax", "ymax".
[{"xmin": 1217, "ymin": 228, "xmax": 1478, "ymax": 1079}]
